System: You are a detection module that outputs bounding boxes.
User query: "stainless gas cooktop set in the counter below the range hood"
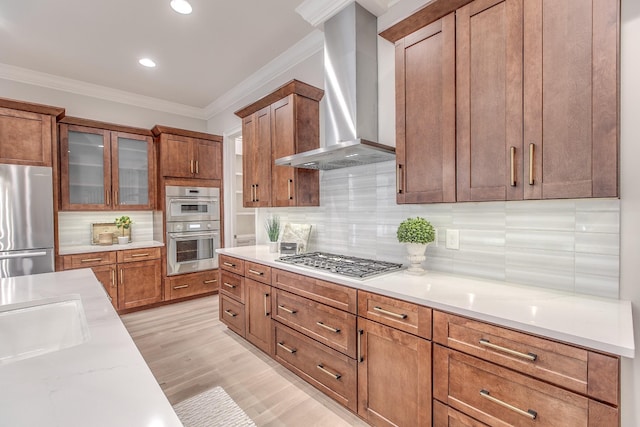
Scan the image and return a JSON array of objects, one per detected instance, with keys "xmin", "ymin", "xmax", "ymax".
[{"xmin": 278, "ymin": 252, "xmax": 402, "ymax": 279}]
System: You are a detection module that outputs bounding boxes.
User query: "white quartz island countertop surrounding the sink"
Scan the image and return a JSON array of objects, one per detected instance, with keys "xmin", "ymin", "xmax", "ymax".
[{"xmin": 0, "ymin": 269, "xmax": 182, "ymax": 427}]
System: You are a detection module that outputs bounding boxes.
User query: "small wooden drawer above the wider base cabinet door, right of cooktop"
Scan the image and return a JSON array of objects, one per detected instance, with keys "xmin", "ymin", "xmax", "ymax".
[{"xmin": 358, "ymin": 291, "xmax": 431, "ymax": 339}]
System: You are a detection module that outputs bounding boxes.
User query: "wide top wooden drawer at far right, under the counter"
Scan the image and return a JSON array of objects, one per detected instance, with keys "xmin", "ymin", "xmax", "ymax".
[{"xmin": 433, "ymin": 311, "xmax": 620, "ymax": 406}]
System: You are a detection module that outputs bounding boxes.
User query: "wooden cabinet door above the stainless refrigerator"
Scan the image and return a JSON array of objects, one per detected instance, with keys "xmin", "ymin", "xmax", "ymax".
[{"xmin": 0, "ymin": 108, "xmax": 54, "ymax": 166}]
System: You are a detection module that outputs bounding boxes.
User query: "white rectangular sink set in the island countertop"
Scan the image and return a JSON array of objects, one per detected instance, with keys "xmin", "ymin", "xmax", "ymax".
[{"xmin": 0, "ymin": 294, "xmax": 90, "ymax": 364}]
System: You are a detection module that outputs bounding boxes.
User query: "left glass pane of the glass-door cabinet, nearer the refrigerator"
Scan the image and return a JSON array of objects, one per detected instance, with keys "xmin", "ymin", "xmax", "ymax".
[{"xmin": 69, "ymin": 130, "xmax": 108, "ymax": 205}]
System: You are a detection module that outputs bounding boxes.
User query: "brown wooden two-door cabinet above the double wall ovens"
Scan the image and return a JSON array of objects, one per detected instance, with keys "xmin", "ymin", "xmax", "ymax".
[{"xmin": 152, "ymin": 125, "xmax": 222, "ymax": 179}]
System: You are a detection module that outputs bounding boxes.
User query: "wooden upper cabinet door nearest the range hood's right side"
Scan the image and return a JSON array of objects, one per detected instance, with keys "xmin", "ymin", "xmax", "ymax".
[{"xmin": 396, "ymin": 14, "xmax": 456, "ymax": 203}]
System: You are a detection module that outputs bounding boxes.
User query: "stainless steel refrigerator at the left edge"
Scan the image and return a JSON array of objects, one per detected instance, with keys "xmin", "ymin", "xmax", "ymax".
[{"xmin": 0, "ymin": 164, "xmax": 54, "ymax": 278}]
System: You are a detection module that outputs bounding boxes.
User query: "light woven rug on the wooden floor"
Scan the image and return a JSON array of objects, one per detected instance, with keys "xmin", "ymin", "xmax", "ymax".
[{"xmin": 173, "ymin": 387, "xmax": 255, "ymax": 427}]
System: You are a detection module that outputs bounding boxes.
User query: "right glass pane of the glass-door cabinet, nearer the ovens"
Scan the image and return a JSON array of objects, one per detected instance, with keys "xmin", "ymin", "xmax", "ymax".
[{"xmin": 118, "ymin": 137, "xmax": 149, "ymax": 205}]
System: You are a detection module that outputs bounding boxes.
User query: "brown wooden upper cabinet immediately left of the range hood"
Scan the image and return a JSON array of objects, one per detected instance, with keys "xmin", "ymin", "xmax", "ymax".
[{"xmin": 235, "ymin": 80, "xmax": 324, "ymax": 207}]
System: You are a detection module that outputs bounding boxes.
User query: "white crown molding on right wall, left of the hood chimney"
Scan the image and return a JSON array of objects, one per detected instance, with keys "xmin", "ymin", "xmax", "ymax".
[{"xmin": 204, "ymin": 30, "xmax": 324, "ymax": 119}]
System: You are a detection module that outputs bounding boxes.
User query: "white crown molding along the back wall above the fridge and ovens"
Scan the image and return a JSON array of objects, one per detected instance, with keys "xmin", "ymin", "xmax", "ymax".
[{"xmin": 0, "ymin": 63, "xmax": 206, "ymax": 120}]
